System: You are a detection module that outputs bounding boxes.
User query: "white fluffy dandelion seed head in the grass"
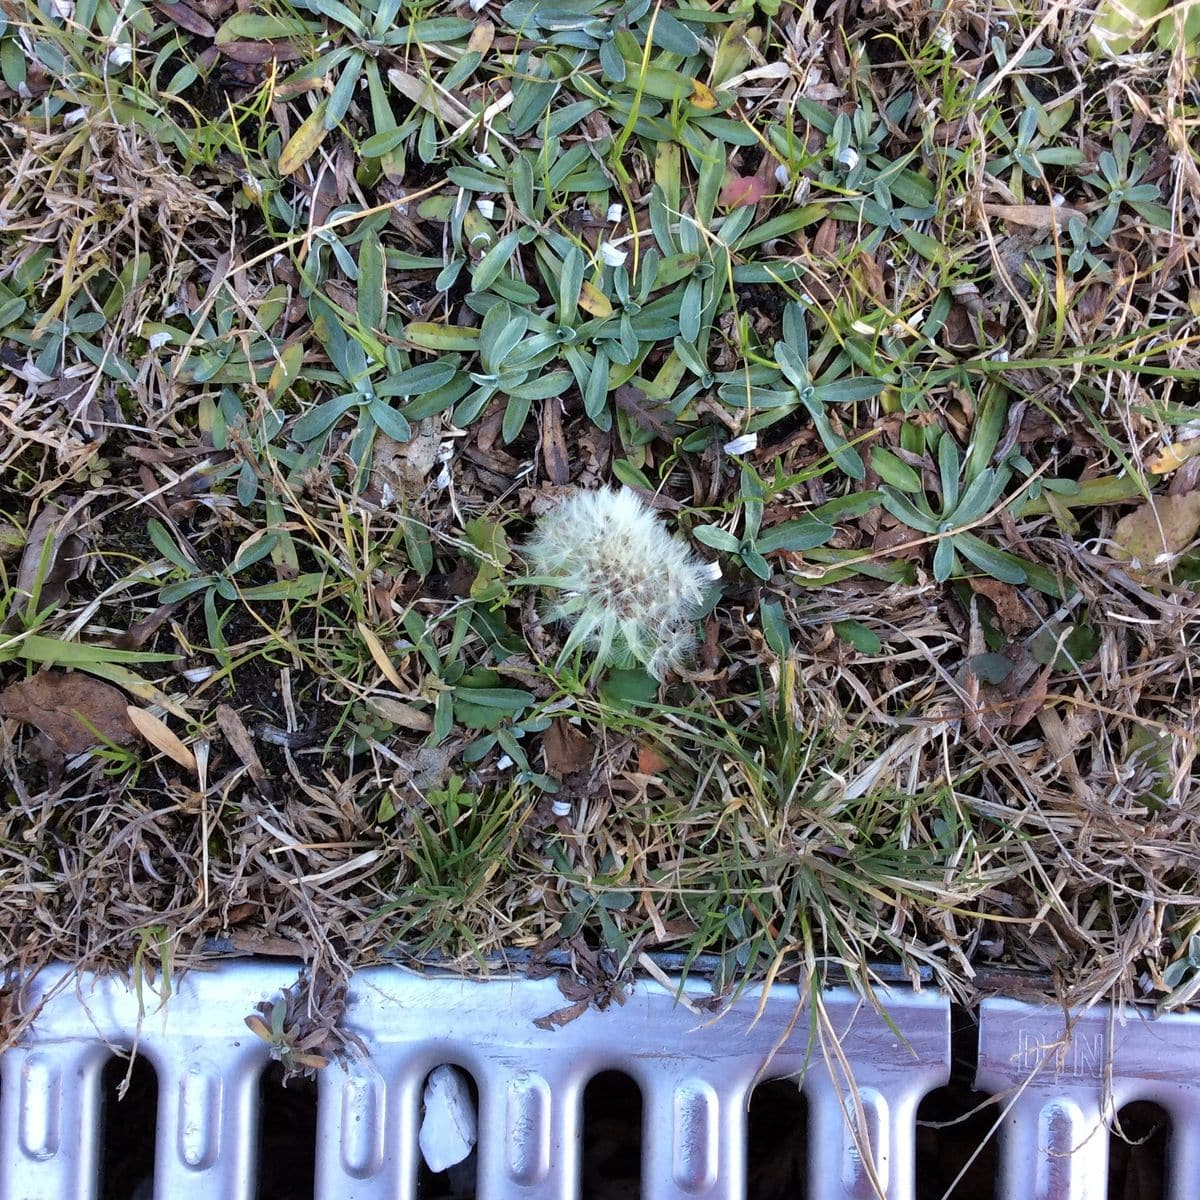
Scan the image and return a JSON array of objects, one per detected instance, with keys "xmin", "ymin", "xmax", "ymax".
[{"xmin": 524, "ymin": 487, "xmax": 709, "ymax": 679}]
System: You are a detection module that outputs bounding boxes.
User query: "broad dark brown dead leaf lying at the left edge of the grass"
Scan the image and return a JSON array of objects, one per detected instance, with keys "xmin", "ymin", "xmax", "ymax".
[{"xmin": 0, "ymin": 671, "xmax": 136, "ymax": 754}]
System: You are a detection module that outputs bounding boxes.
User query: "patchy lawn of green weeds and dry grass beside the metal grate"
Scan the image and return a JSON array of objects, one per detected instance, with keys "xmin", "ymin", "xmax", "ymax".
[{"xmin": 0, "ymin": 0, "xmax": 1200, "ymax": 1022}]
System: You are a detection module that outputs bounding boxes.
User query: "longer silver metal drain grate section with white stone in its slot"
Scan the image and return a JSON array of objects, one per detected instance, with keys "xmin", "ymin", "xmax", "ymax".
[{"xmin": 0, "ymin": 962, "xmax": 950, "ymax": 1200}]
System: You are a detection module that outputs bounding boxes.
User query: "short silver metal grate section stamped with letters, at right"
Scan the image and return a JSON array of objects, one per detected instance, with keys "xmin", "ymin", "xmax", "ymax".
[{"xmin": 976, "ymin": 1000, "xmax": 1200, "ymax": 1200}]
